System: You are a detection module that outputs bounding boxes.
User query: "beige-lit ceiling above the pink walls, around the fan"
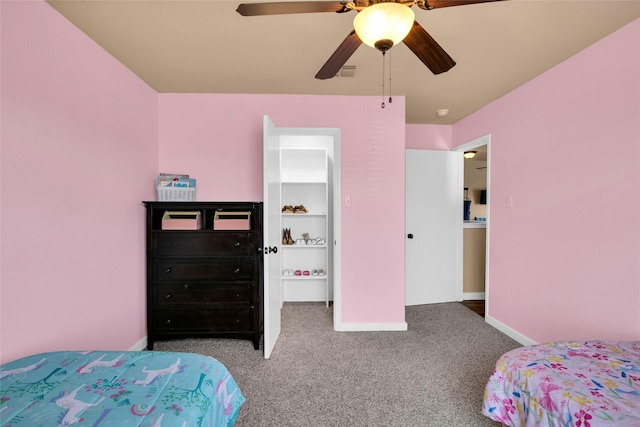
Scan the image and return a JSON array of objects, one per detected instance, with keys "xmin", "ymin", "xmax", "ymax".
[{"xmin": 48, "ymin": 0, "xmax": 640, "ymax": 124}]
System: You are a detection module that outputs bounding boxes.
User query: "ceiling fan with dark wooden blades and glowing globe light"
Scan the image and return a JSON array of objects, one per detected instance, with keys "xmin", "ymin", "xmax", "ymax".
[{"xmin": 236, "ymin": 0, "xmax": 501, "ymax": 80}]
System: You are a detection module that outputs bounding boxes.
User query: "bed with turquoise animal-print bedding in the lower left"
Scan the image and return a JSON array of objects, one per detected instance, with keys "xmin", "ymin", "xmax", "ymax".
[{"xmin": 0, "ymin": 351, "xmax": 245, "ymax": 427}]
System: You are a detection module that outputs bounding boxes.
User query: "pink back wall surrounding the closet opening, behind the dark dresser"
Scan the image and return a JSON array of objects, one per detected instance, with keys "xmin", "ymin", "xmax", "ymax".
[{"xmin": 159, "ymin": 94, "xmax": 405, "ymax": 323}]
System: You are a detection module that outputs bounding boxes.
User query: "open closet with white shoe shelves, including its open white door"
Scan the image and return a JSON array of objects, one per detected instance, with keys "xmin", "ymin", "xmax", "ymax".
[{"xmin": 263, "ymin": 116, "xmax": 340, "ymax": 358}]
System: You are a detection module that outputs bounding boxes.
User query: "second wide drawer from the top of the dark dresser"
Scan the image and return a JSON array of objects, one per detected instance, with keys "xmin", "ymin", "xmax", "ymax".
[{"xmin": 154, "ymin": 259, "xmax": 254, "ymax": 282}]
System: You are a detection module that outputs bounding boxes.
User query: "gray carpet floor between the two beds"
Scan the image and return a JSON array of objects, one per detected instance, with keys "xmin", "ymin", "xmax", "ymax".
[{"xmin": 155, "ymin": 303, "xmax": 519, "ymax": 427}]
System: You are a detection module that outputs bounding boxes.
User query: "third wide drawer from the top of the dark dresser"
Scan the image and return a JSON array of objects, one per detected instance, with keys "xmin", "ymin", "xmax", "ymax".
[{"xmin": 153, "ymin": 283, "xmax": 253, "ymax": 307}]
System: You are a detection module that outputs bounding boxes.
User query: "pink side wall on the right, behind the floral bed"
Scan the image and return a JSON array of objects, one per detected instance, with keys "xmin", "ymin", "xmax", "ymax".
[{"xmin": 453, "ymin": 20, "xmax": 640, "ymax": 342}]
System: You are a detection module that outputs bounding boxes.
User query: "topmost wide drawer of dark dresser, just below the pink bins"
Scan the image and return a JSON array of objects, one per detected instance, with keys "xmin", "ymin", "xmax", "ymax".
[{"xmin": 152, "ymin": 231, "xmax": 257, "ymax": 257}]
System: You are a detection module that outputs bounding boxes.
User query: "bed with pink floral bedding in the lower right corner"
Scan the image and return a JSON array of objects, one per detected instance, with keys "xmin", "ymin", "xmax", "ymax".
[{"xmin": 482, "ymin": 341, "xmax": 640, "ymax": 427}]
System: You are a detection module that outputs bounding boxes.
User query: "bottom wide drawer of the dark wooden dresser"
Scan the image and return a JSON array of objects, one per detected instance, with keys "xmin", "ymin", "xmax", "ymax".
[{"xmin": 153, "ymin": 308, "xmax": 253, "ymax": 333}]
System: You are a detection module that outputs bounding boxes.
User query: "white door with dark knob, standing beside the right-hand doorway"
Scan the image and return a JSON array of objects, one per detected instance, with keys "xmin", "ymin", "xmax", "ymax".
[{"xmin": 405, "ymin": 150, "xmax": 464, "ymax": 305}]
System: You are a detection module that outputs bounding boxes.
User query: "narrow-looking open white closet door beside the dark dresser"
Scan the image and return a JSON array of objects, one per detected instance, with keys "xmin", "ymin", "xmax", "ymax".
[{"xmin": 262, "ymin": 116, "xmax": 282, "ymax": 359}]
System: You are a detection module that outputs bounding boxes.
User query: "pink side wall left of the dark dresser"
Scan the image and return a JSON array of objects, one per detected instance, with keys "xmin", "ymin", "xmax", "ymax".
[{"xmin": 0, "ymin": 1, "xmax": 158, "ymax": 362}]
